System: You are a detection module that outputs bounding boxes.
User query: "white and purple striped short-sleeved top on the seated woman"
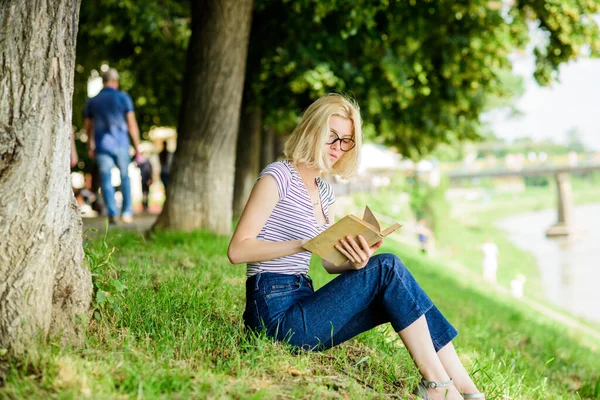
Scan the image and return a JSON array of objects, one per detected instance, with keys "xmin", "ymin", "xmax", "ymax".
[{"xmin": 246, "ymin": 160, "xmax": 335, "ymax": 277}]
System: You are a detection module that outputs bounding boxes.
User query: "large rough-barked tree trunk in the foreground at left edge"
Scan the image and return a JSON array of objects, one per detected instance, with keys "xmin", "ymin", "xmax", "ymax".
[{"xmin": 0, "ymin": 0, "xmax": 92, "ymax": 355}]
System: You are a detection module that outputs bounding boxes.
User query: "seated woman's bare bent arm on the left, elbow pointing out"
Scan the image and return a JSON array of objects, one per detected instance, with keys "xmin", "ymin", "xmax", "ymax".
[{"xmin": 227, "ymin": 175, "xmax": 308, "ymax": 264}]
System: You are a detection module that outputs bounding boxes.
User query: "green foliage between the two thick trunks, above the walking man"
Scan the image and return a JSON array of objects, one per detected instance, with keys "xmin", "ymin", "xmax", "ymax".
[{"xmin": 73, "ymin": 0, "xmax": 191, "ymax": 132}]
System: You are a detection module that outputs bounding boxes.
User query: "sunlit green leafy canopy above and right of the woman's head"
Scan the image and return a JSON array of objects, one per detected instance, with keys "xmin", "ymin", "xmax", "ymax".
[{"xmin": 247, "ymin": 0, "xmax": 600, "ymax": 156}]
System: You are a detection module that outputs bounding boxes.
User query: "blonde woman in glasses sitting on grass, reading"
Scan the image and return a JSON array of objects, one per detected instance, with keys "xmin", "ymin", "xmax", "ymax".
[{"xmin": 227, "ymin": 94, "xmax": 484, "ymax": 400}]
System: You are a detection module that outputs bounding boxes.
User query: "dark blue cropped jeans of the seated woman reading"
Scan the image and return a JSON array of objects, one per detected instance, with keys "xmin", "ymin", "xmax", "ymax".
[{"xmin": 244, "ymin": 254, "xmax": 457, "ymax": 351}]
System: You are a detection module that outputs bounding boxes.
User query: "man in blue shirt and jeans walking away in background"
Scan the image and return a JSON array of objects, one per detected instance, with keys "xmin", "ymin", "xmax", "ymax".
[{"xmin": 85, "ymin": 68, "xmax": 140, "ymax": 224}]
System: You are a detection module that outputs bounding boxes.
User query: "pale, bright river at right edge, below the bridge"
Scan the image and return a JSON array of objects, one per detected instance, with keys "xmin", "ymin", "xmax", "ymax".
[{"xmin": 498, "ymin": 204, "xmax": 600, "ymax": 322}]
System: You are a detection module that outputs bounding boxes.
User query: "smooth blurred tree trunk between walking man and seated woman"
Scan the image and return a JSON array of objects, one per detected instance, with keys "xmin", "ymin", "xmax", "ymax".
[{"xmin": 155, "ymin": 0, "xmax": 252, "ymax": 234}]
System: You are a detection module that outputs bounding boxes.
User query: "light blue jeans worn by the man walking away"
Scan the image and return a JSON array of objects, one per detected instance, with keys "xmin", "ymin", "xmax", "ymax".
[{"xmin": 96, "ymin": 148, "xmax": 133, "ymax": 218}]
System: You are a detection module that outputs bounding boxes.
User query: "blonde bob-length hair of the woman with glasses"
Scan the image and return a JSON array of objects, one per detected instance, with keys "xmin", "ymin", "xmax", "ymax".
[{"xmin": 284, "ymin": 93, "xmax": 362, "ymax": 178}]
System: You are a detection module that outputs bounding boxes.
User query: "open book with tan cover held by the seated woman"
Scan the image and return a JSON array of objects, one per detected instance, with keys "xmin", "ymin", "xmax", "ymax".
[{"xmin": 303, "ymin": 207, "xmax": 402, "ymax": 266}]
